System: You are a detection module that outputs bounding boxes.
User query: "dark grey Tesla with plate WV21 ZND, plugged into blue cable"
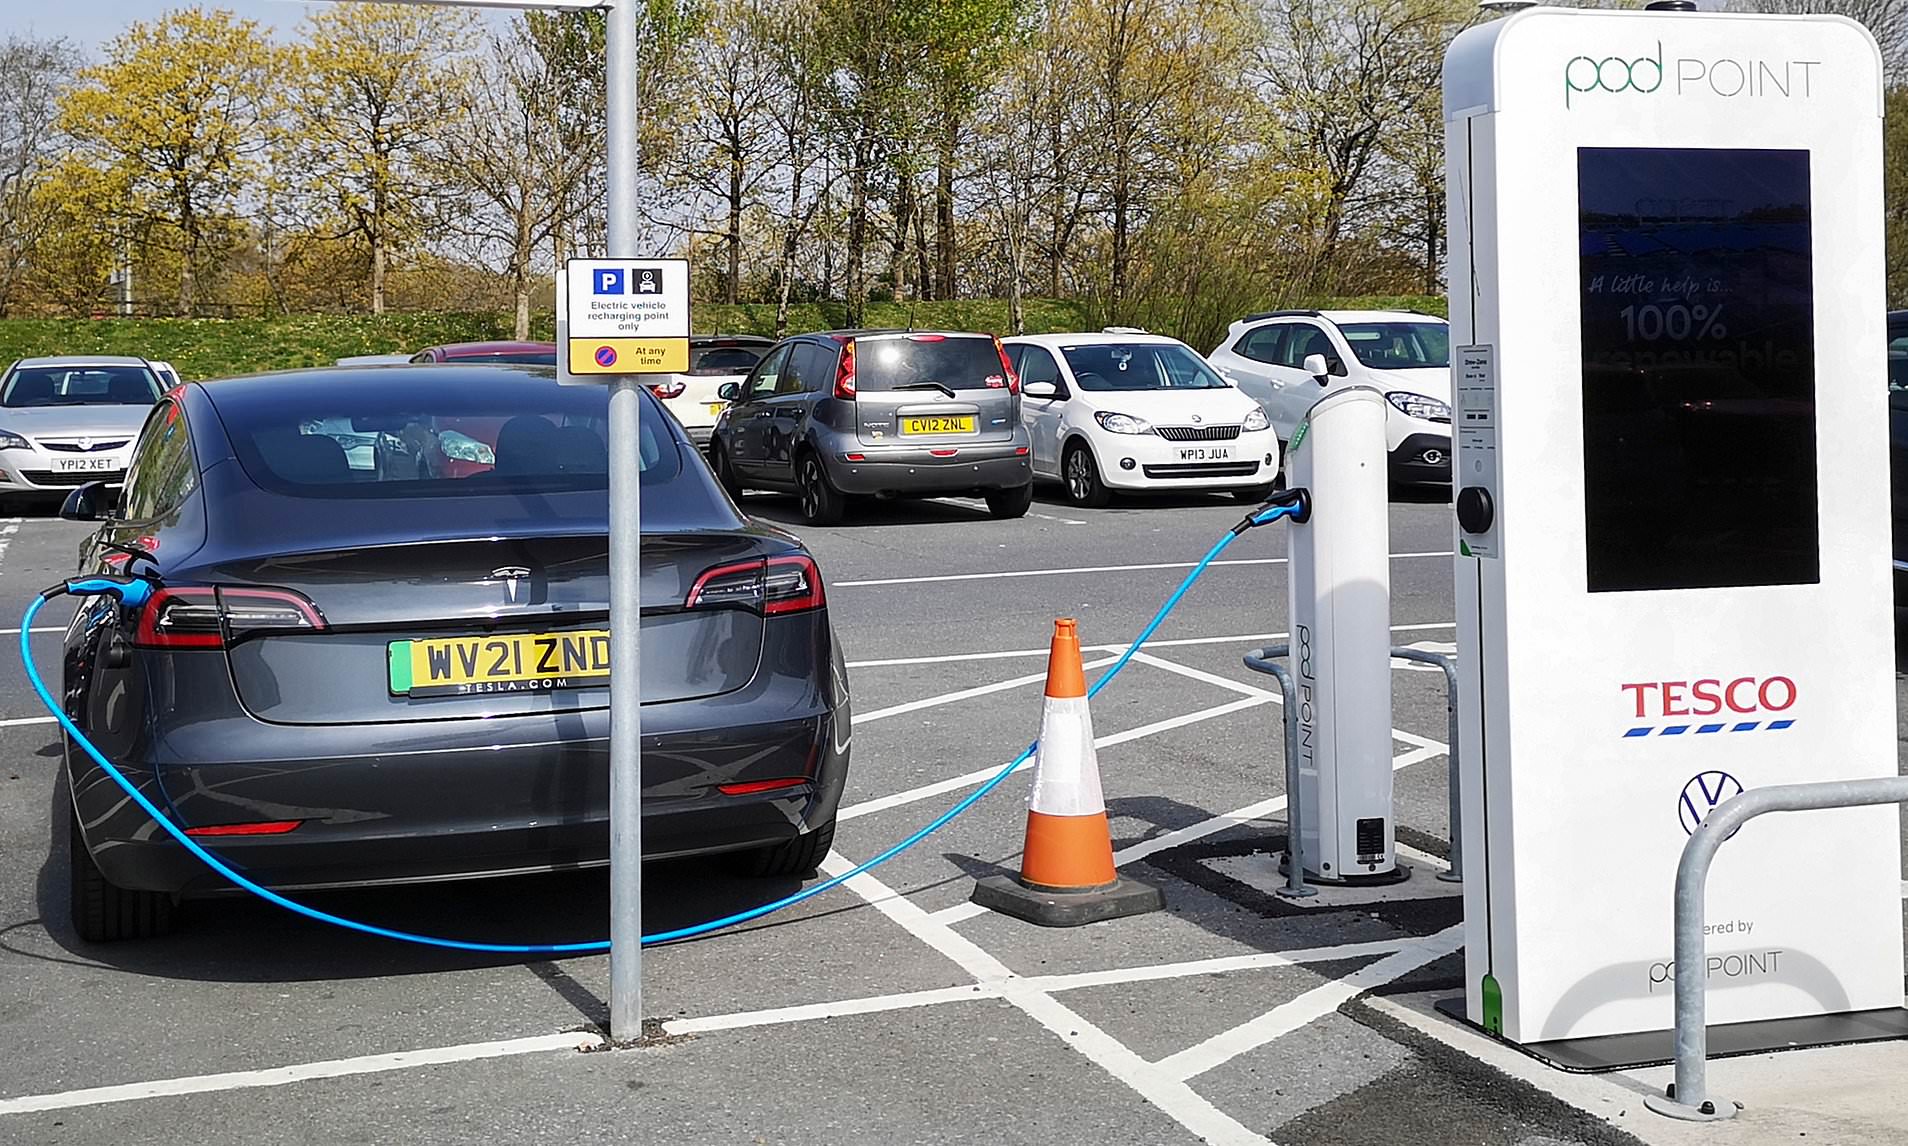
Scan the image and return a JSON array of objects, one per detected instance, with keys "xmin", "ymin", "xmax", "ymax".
[{"xmin": 61, "ymin": 366, "xmax": 849, "ymax": 940}]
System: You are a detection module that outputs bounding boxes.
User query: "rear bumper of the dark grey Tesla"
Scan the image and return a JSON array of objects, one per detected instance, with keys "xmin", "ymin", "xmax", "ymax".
[{"xmin": 74, "ymin": 706, "xmax": 847, "ymax": 894}]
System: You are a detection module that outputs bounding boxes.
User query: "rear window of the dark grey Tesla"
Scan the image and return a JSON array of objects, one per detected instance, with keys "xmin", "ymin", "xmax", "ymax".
[{"xmin": 218, "ymin": 383, "xmax": 683, "ymax": 498}]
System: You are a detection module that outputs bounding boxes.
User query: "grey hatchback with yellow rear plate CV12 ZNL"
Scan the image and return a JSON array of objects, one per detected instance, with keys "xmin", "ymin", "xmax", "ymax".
[{"xmin": 710, "ymin": 330, "xmax": 1034, "ymax": 524}]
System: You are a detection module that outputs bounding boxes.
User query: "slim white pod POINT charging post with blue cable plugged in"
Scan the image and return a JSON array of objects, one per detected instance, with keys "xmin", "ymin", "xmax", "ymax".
[{"xmin": 1286, "ymin": 387, "xmax": 1410, "ymax": 883}]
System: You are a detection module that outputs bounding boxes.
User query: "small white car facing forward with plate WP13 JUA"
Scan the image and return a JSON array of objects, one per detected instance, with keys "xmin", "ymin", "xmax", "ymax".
[{"xmin": 1002, "ymin": 330, "xmax": 1280, "ymax": 505}]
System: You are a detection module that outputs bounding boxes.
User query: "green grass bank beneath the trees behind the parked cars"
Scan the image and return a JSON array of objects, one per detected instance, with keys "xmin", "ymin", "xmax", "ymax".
[{"xmin": 0, "ymin": 296, "xmax": 1444, "ymax": 378}]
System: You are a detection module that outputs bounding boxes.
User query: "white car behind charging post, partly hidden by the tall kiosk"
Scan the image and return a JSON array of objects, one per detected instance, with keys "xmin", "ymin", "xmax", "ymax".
[{"xmin": 1208, "ymin": 311, "xmax": 1450, "ymax": 482}]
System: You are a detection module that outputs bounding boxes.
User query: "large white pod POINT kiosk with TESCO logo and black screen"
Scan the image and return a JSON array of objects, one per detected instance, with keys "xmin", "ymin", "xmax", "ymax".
[{"xmin": 1450, "ymin": 8, "xmax": 1902, "ymax": 1066}]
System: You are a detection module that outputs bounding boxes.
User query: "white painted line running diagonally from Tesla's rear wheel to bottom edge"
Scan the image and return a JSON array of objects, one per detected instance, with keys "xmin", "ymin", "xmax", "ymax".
[{"xmin": 822, "ymin": 852, "xmax": 1269, "ymax": 1146}]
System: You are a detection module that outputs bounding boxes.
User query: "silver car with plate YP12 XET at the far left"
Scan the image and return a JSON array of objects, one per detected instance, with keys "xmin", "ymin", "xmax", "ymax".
[{"xmin": 0, "ymin": 355, "xmax": 160, "ymax": 498}]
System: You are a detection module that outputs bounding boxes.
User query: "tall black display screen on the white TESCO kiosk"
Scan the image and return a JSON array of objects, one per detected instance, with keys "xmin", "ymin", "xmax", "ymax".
[{"xmin": 1578, "ymin": 147, "xmax": 1820, "ymax": 593}]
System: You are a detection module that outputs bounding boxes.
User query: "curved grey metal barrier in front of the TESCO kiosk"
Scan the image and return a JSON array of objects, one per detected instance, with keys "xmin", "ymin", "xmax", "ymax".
[{"xmin": 1643, "ymin": 776, "xmax": 1908, "ymax": 1121}]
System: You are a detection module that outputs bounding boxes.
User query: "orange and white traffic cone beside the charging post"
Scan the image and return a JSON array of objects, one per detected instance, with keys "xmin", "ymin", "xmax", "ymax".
[{"xmin": 973, "ymin": 620, "xmax": 1166, "ymax": 927}]
